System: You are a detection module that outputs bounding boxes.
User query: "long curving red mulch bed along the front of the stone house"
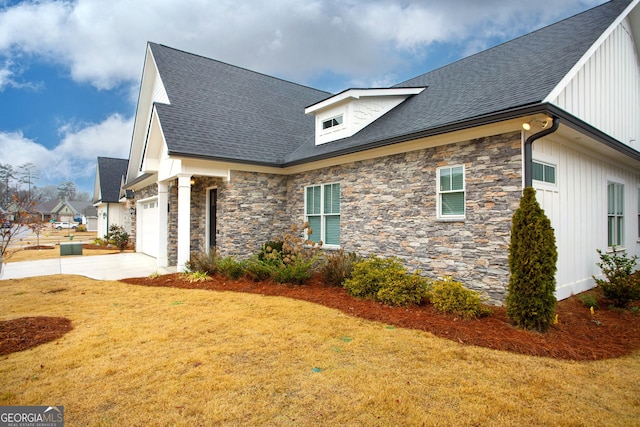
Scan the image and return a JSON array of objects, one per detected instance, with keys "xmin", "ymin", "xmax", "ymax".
[{"xmin": 123, "ymin": 274, "xmax": 640, "ymax": 360}]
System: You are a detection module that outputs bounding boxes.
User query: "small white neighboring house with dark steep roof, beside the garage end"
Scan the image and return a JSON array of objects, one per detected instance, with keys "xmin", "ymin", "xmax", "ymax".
[{"xmin": 93, "ymin": 157, "xmax": 128, "ymax": 237}]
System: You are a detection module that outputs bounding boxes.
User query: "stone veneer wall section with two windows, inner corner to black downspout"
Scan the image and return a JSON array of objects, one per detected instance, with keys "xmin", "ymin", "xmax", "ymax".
[{"xmin": 288, "ymin": 132, "xmax": 522, "ymax": 302}]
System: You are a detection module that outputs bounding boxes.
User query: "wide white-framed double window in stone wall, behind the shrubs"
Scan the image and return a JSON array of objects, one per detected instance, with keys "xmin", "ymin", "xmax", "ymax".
[{"xmin": 305, "ymin": 184, "xmax": 340, "ymax": 246}]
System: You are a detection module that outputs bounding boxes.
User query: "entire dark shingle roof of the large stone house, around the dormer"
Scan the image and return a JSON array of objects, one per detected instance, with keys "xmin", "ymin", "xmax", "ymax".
[{"xmin": 150, "ymin": 0, "xmax": 631, "ymax": 166}]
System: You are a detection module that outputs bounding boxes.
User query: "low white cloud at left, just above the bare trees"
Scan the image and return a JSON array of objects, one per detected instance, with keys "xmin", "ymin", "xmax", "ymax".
[{"xmin": 0, "ymin": 114, "xmax": 133, "ymax": 191}]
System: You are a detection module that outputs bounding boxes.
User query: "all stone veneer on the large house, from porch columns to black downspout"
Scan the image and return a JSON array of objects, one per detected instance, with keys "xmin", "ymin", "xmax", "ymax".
[{"xmin": 164, "ymin": 132, "xmax": 522, "ymax": 302}]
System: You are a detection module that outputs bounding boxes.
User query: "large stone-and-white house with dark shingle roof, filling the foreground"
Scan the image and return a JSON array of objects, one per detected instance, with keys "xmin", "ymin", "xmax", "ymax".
[{"xmin": 126, "ymin": 0, "xmax": 640, "ymax": 301}]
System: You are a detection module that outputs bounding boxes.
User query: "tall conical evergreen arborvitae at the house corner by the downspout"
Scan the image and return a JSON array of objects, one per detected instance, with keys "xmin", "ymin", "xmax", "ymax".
[{"xmin": 507, "ymin": 187, "xmax": 558, "ymax": 332}]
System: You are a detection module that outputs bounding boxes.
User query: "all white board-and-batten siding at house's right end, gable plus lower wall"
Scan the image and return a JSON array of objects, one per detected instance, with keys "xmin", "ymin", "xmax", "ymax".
[{"xmin": 533, "ymin": 14, "xmax": 640, "ymax": 299}]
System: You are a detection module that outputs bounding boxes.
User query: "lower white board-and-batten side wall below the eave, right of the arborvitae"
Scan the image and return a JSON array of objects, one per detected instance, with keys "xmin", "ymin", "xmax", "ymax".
[{"xmin": 533, "ymin": 135, "xmax": 640, "ymax": 299}]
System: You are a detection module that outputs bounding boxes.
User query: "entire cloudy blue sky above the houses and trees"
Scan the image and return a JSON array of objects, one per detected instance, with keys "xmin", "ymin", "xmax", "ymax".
[{"xmin": 0, "ymin": 0, "xmax": 605, "ymax": 195}]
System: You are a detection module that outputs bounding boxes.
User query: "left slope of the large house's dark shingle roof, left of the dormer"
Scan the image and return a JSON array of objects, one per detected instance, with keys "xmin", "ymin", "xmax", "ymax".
[{"xmin": 150, "ymin": 43, "xmax": 329, "ymax": 164}]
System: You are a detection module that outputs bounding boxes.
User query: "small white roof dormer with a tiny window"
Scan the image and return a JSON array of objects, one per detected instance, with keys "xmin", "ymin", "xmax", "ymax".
[{"xmin": 304, "ymin": 87, "xmax": 425, "ymax": 145}]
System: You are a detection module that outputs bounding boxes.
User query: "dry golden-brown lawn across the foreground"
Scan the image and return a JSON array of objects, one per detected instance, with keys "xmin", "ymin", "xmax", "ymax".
[{"xmin": 0, "ymin": 276, "xmax": 640, "ymax": 426}]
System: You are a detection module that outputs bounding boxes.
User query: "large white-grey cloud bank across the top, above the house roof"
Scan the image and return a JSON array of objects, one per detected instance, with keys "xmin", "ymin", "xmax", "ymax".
[{"xmin": 0, "ymin": 0, "xmax": 604, "ymax": 89}]
